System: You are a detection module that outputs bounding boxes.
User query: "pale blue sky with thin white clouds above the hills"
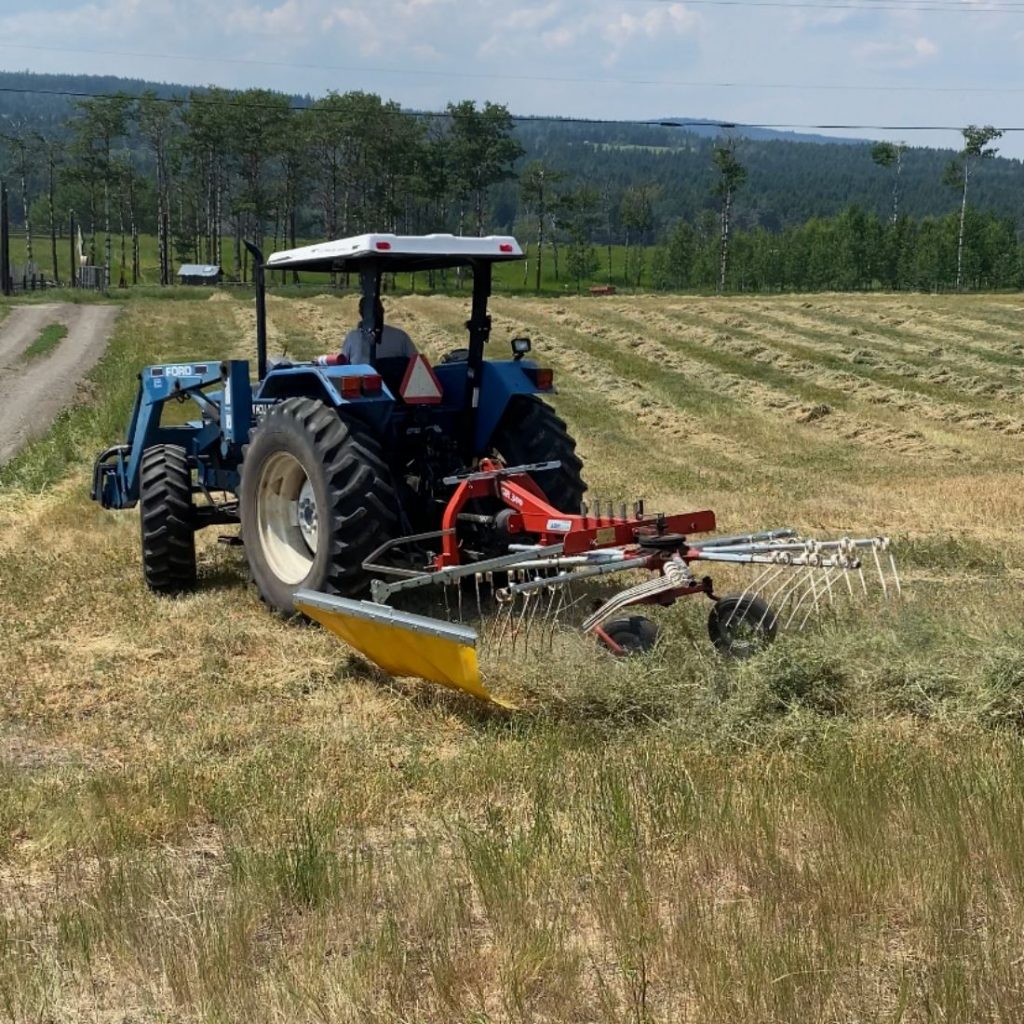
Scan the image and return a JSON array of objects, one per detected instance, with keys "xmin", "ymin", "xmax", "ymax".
[{"xmin": 0, "ymin": 0, "xmax": 1024, "ymax": 158}]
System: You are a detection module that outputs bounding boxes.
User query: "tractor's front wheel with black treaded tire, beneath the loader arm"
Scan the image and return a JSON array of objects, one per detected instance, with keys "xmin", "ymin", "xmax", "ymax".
[{"xmin": 138, "ymin": 444, "xmax": 196, "ymax": 594}]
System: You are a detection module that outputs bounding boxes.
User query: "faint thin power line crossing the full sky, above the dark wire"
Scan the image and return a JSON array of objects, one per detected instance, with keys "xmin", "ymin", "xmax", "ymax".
[{"xmin": 0, "ymin": 43, "xmax": 1024, "ymax": 94}]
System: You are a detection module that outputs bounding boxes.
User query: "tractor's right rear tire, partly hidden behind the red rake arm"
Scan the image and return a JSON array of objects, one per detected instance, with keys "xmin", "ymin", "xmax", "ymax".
[{"xmin": 490, "ymin": 394, "xmax": 587, "ymax": 513}]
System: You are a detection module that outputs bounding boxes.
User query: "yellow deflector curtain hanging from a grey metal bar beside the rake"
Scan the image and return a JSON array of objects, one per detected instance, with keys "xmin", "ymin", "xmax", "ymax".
[{"xmin": 295, "ymin": 590, "xmax": 509, "ymax": 708}]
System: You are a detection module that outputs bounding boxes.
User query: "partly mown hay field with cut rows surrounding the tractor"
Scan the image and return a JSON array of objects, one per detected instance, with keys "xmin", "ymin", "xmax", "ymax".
[{"xmin": 0, "ymin": 292, "xmax": 1024, "ymax": 1024}]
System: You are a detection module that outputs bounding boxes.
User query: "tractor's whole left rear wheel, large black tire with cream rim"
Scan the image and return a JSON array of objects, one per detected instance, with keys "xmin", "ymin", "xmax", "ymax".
[{"xmin": 239, "ymin": 398, "xmax": 398, "ymax": 615}]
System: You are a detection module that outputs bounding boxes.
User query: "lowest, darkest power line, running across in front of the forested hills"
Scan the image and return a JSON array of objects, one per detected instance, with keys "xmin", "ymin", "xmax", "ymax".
[{"xmin": 0, "ymin": 86, "xmax": 1011, "ymax": 134}]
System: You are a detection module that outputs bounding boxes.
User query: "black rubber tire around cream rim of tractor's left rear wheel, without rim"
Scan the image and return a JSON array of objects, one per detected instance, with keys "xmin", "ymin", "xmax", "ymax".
[{"xmin": 239, "ymin": 398, "xmax": 398, "ymax": 615}]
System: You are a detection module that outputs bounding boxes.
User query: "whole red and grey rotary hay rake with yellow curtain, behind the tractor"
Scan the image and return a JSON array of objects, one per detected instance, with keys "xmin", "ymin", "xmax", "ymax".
[{"xmin": 295, "ymin": 460, "xmax": 901, "ymax": 707}]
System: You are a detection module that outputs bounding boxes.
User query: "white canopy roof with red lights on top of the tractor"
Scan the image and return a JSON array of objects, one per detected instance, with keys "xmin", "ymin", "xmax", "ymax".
[{"xmin": 266, "ymin": 234, "xmax": 523, "ymax": 273}]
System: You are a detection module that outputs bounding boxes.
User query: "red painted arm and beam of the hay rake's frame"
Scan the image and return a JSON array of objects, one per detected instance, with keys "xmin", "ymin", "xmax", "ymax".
[{"xmin": 434, "ymin": 459, "xmax": 715, "ymax": 568}]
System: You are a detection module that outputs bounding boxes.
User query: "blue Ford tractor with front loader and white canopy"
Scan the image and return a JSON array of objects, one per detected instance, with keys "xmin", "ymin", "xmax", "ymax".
[{"xmin": 92, "ymin": 234, "xmax": 586, "ymax": 614}]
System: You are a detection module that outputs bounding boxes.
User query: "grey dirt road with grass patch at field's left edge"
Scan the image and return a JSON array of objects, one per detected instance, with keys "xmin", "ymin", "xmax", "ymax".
[{"xmin": 0, "ymin": 303, "xmax": 119, "ymax": 465}]
